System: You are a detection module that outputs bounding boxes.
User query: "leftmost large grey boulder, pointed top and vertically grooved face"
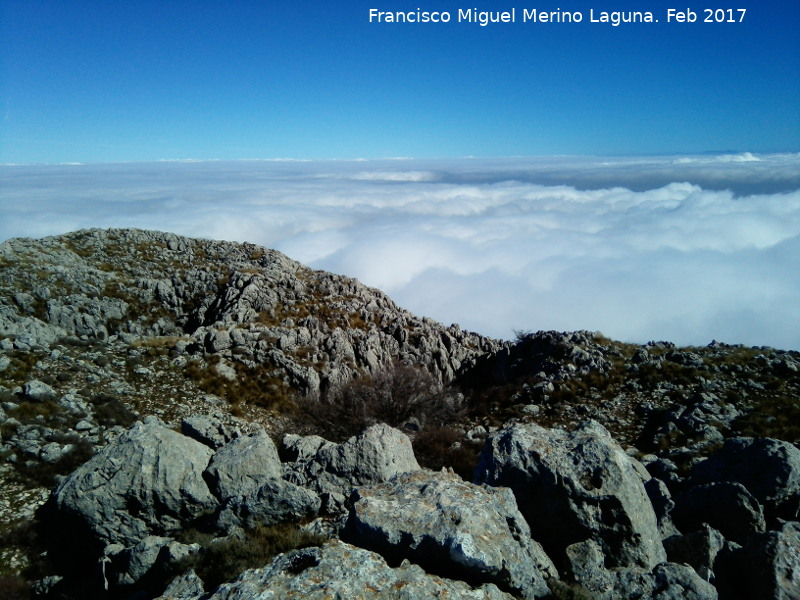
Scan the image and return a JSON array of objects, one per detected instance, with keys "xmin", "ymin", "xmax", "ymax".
[{"xmin": 52, "ymin": 417, "xmax": 218, "ymax": 546}]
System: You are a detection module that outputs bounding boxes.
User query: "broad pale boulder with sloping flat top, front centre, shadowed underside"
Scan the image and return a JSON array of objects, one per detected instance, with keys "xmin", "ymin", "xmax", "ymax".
[{"xmin": 343, "ymin": 471, "xmax": 558, "ymax": 598}]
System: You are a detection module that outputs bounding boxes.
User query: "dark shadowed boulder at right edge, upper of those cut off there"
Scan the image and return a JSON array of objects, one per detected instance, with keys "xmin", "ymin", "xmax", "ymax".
[{"xmin": 692, "ymin": 438, "xmax": 800, "ymax": 518}]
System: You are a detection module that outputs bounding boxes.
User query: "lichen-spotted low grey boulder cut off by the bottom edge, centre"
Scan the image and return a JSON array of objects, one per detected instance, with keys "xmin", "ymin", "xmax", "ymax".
[{"xmin": 194, "ymin": 541, "xmax": 513, "ymax": 600}]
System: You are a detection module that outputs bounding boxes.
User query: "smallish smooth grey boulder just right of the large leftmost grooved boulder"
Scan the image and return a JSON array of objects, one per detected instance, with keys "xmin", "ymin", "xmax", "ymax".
[{"xmin": 204, "ymin": 431, "xmax": 281, "ymax": 501}]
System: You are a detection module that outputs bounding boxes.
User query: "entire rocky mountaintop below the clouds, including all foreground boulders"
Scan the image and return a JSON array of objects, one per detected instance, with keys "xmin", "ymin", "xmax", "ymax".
[{"xmin": 0, "ymin": 229, "xmax": 800, "ymax": 600}]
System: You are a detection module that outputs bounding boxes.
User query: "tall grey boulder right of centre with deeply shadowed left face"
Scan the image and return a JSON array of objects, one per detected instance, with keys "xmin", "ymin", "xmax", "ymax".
[{"xmin": 475, "ymin": 421, "xmax": 666, "ymax": 569}]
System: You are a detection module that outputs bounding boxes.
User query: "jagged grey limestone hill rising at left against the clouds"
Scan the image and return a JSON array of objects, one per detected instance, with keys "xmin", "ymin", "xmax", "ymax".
[{"xmin": 0, "ymin": 229, "xmax": 500, "ymax": 394}]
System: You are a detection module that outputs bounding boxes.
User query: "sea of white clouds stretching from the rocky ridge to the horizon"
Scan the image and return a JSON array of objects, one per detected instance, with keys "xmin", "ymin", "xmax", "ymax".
[{"xmin": 0, "ymin": 153, "xmax": 800, "ymax": 349}]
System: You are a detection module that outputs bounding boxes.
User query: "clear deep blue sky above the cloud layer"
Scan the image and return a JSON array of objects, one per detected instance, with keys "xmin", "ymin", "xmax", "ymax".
[{"xmin": 0, "ymin": 0, "xmax": 800, "ymax": 163}]
